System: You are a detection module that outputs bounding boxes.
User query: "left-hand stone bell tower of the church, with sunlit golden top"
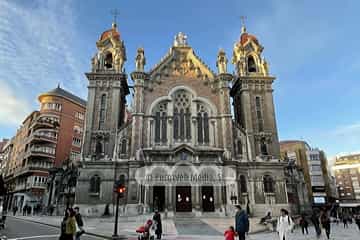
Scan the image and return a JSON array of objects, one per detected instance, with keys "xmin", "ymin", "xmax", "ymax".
[{"xmin": 83, "ymin": 23, "xmax": 129, "ymax": 161}]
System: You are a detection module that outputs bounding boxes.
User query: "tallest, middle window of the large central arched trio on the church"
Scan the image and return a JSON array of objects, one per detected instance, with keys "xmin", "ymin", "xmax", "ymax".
[{"xmin": 174, "ymin": 90, "xmax": 191, "ymax": 141}]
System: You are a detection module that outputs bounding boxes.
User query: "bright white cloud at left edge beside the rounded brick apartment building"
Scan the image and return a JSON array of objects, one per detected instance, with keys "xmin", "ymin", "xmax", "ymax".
[{"xmin": 0, "ymin": 84, "xmax": 31, "ymax": 126}]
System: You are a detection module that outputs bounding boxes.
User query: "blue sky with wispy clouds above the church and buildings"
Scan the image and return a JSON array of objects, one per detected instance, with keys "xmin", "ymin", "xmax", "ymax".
[{"xmin": 0, "ymin": 0, "xmax": 360, "ymax": 161}]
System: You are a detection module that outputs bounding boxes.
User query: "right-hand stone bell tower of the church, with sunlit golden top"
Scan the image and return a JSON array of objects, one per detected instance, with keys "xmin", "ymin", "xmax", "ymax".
[{"xmin": 231, "ymin": 25, "xmax": 280, "ymax": 161}]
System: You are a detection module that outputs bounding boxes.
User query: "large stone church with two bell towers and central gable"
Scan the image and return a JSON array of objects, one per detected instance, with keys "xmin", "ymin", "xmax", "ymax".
[{"xmin": 75, "ymin": 24, "xmax": 288, "ymax": 217}]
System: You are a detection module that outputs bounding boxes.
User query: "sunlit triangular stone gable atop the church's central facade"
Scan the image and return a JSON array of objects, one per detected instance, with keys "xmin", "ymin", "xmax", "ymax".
[{"xmin": 149, "ymin": 46, "xmax": 216, "ymax": 81}]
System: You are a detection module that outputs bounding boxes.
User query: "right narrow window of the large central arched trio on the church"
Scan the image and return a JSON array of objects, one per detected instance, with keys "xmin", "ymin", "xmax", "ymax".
[{"xmin": 197, "ymin": 104, "xmax": 210, "ymax": 144}]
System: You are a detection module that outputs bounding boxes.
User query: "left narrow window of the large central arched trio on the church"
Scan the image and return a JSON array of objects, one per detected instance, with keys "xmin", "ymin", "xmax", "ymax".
[{"xmin": 155, "ymin": 102, "xmax": 167, "ymax": 143}]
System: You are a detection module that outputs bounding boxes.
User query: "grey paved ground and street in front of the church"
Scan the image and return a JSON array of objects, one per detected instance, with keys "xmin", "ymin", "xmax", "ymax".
[{"xmin": 0, "ymin": 216, "xmax": 360, "ymax": 240}]
